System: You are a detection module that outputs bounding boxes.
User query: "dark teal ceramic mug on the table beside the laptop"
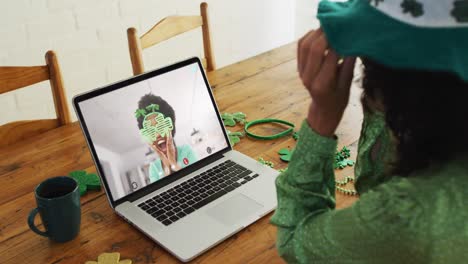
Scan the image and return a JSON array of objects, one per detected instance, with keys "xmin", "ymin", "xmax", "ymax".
[{"xmin": 28, "ymin": 176, "xmax": 81, "ymax": 242}]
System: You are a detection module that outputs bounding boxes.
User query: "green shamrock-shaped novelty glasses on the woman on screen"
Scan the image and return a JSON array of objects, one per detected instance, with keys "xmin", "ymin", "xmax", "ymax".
[{"xmin": 140, "ymin": 112, "xmax": 174, "ymax": 144}]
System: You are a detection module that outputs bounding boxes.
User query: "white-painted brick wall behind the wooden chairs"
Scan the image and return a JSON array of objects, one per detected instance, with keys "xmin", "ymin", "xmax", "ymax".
[{"xmin": 0, "ymin": 0, "xmax": 318, "ymax": 125}]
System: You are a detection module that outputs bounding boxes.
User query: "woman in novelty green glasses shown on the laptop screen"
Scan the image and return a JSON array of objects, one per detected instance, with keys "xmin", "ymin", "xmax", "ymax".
[{"xmin": 135, "ymin": 94, "xmax": 197, "ymax": 182}]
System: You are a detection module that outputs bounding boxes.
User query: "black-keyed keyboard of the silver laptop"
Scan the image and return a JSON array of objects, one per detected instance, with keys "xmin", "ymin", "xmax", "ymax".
[{"xmin": 138, "ymin": 160, "xmax": 258, "ymax": 226}]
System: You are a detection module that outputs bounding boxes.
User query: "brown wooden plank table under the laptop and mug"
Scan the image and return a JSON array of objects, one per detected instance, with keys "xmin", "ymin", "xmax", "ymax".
[{"xmin": 0, "ymin": 43, "xmax": 362, "ymax": 263}]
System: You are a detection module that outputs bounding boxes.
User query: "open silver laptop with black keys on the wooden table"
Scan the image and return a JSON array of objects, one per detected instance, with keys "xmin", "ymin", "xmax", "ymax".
[{"xmin": 73, "ymin": 58, "xmax": 278, "ymax": 262}]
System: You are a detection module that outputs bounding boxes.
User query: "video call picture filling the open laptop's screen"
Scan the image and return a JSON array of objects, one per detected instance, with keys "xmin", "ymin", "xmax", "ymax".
[{"xmin": 80, "ymin": 64, "xmax": 227, "ymax": 200}]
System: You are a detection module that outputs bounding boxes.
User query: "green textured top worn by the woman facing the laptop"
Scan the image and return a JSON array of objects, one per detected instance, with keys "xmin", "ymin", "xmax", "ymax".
[{"xmin": 271, "ymin": 113, "xmax": 468, "ymax": 264}]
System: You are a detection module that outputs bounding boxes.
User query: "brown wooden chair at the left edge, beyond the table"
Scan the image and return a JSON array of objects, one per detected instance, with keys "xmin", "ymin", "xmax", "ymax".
[{"xmin": 0, "ymin": 51, "xmax": 71, "ymax": 147}]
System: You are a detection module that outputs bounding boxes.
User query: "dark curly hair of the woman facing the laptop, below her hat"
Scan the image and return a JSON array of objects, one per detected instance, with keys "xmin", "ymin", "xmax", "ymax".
[{"xmin": 362, "ymin": 58, "xmax": 468, "ymax": 176}]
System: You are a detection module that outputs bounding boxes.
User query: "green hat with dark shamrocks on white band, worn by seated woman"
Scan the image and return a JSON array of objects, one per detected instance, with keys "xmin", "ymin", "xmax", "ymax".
[{"xmin": 317, "ymin": 0, "xmax": 468, "ymax": 82}]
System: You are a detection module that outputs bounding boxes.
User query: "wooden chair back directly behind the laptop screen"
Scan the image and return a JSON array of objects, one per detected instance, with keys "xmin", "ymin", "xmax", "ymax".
[{"xmin": 127, "ymin": 3, "xmax": 216, "ymax": 75}]
